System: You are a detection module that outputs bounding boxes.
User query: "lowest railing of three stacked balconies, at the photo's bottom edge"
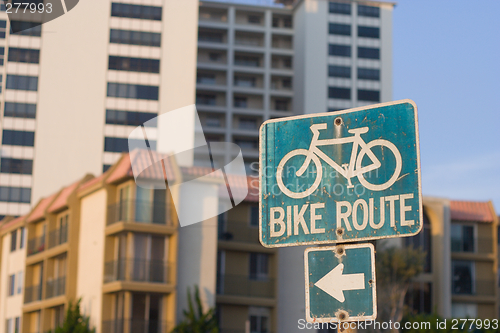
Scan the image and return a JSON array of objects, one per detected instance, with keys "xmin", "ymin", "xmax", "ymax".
[{"xmin": 102, "ymin": 319, "xmax": 173, "ymax": 333}]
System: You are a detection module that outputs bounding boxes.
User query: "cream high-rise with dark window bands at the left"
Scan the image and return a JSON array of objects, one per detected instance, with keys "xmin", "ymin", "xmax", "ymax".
[{"xmin": 0, "ymin": 0, "xmax": 198, "ymax": 216}]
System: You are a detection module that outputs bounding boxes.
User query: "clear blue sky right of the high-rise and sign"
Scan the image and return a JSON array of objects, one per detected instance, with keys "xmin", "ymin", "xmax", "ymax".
[{"xmin": 393, "ymin": 0, "xmax": 500, "ymax": 212}]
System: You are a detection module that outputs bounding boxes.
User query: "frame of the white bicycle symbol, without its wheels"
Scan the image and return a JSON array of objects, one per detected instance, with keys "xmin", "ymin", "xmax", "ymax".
[{"xmin": 297, "ymin": 124, "xmax": 382, "ymax": 187}]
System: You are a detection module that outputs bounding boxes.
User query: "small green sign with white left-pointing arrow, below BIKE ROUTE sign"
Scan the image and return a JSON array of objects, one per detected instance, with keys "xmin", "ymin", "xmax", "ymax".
[{"xmin": 304, "ymin": 243, "xmax": 377, "ymax": 323}]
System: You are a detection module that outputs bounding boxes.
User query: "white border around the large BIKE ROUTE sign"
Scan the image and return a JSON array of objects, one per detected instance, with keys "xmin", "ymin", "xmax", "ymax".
[{"xmin": 259, "ymin": 99, "xmax": 424, "ymax": 248}]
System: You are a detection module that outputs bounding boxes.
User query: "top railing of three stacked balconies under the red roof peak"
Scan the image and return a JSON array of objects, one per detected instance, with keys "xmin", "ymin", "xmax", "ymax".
[{"xmin": 107, "ymin": 200, "xmax": 172, "ymax": 225}]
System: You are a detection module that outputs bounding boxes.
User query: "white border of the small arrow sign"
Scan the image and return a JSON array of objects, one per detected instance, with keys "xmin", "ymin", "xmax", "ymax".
[{"xmin": 304, "ymin": 243, "xmax": 377, "ymax": 323}]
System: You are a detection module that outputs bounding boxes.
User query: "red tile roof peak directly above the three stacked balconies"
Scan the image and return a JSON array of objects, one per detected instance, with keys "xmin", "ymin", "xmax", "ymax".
[{"xmin": 106, "ymin": 149, "xmax": 175, "ymax": 184}]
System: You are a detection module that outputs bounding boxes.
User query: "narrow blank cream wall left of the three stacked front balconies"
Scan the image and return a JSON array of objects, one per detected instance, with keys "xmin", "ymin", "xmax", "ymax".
[{"xmin": 76, "ymin": 189, "xmax": 107, "ymax": 333}]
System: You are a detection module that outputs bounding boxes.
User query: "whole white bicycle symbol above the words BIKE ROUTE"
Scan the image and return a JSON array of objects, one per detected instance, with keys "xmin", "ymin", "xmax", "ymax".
[{"xmin": 276, "ymin": 123, "xmax": 403, "ymax": 199}]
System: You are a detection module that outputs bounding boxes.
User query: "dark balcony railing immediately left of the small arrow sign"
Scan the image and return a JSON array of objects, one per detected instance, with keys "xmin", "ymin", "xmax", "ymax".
[{"xmin": 217, "ymin": 274, "xmax": 275, "ymax": 298}]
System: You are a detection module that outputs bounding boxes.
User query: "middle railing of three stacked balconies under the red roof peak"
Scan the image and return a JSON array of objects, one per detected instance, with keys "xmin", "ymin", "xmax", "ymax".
[{"xmin": 104, "ymin": 259, "xmax": 173, "ymax": 283}]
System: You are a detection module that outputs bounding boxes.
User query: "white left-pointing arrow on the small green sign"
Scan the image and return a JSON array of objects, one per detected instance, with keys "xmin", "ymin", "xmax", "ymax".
[{"xmin": 314, "ymin": 264, "xmax": 365, "ymax": 303}]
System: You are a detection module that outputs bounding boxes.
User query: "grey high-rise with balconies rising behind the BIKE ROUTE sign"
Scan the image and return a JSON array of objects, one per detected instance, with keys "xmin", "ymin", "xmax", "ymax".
[{"xmin": 196, "ymin": 0, "xmax": 394, "ymax": 172}]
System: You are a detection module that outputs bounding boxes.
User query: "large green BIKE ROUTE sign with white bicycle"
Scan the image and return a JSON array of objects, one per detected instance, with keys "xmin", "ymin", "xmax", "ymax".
[{"xmin": 259, "ymin": 100, "xmax": 422, "ymax": 247}]
